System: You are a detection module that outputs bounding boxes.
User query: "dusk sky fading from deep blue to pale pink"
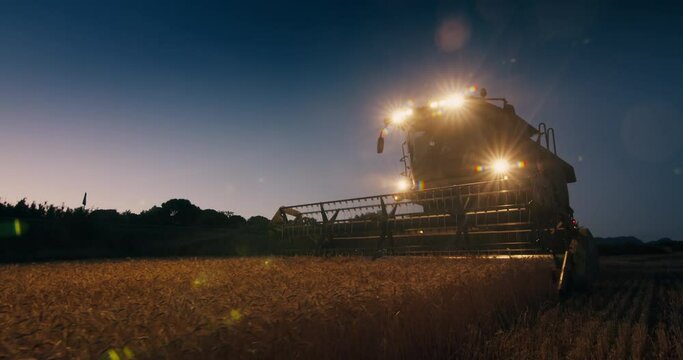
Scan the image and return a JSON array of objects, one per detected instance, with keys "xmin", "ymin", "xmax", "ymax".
[{"xmin": 0, "ymin": 0, "xmax": 683, "ymax": 240}]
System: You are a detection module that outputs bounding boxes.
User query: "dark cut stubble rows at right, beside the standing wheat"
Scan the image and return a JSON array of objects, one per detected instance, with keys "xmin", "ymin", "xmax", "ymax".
[{"xmin": 483, "ymin": 254, "xmax": 683, "ymax": 359}]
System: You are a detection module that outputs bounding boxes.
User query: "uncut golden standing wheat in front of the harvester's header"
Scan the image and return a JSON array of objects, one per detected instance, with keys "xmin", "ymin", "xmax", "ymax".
[{"xmin": 0, "ymin": 258, "xmax": 552, "ymax": 359}]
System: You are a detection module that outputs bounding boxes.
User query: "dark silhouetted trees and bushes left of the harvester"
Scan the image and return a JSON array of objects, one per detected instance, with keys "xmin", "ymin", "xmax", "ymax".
[{"xmin": 0, "ymin": 199, "xmax": 273, "ymax": 262}]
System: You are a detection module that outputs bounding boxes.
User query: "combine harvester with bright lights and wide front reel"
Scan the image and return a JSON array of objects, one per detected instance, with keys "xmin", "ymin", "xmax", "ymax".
[{"xmin": 273, "ymin": 89, "xmax": 597, "ymax": 291}]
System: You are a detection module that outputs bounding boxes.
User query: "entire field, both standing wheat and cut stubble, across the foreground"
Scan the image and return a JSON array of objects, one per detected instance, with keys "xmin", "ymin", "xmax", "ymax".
[{"xmin": 0, "ymin": 257, "xmax": 683, "ymax": 359}]
